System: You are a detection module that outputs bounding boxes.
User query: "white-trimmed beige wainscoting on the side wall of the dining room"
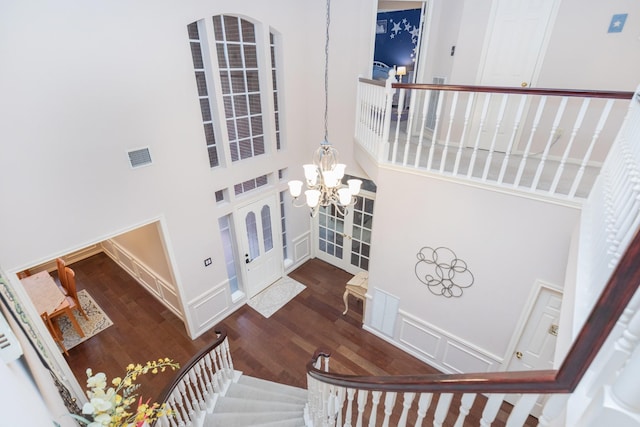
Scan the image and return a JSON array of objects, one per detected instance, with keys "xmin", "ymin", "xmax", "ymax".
[{"xmin": 102, "ymin": 240, "xmax": 184, "ymax": 321}]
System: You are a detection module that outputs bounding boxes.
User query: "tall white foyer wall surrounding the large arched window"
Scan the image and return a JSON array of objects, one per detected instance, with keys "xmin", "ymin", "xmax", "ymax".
[{"xmin": 0, "ymin": 0, "xmax": 375, "ymax": 335}]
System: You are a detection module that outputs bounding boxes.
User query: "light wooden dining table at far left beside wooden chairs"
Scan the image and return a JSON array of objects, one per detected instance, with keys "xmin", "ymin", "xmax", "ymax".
[{"xmin": 20, "ymin": 271, "xmax": 84, "ymax": 337}]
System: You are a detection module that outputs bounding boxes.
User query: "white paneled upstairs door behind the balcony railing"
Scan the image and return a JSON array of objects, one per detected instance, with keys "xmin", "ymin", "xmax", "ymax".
[{"xmin": 474, "ymin": 0, "xmax": 560, "ymax": 151}]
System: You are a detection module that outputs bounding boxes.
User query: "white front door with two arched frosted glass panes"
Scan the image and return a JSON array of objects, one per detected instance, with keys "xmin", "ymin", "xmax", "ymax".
[{"xmin": 235, "ymin": 196, "xmax": 283, "ymax": 298}]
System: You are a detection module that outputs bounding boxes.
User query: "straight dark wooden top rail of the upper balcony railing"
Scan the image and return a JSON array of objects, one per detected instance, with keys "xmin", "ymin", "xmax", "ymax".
[{"xmin": 359, "ymin": 77, "xmax": 634, "ymax": 99}]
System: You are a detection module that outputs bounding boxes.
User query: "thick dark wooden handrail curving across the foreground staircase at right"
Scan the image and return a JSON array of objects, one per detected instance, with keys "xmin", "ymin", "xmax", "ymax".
[{"xmin": 307, "ymin": 232, "xmax": 640, "ymax": 393}]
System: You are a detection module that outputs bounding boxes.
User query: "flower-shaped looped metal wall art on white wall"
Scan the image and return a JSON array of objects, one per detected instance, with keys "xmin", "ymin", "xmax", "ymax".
[{"xmin": 415, "ymin": 246, "xmax": 474, "ymax": 298}]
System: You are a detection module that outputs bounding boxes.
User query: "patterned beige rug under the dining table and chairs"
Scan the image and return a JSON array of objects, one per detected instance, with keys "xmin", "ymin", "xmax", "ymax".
[{"xmin": 56, "ymin": 289, "xmax": 113, "ymax": 350}]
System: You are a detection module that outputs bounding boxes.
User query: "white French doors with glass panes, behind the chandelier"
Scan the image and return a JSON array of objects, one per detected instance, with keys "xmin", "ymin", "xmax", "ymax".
[{"xmin": 316, "ymin": 191, "xmax": 374, "ymax": 274}]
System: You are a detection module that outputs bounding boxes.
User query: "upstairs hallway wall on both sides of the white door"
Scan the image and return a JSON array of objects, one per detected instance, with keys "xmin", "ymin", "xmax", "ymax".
[{"xmin": 438, "ymin": 0, "xmax": 640, "ymax": 91}]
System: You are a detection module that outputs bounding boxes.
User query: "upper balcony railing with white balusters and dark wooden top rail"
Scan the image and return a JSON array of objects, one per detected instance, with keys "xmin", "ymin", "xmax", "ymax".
[{"xmin": 355, "ymin": 76, "xmax": 633, "ymax": 200}]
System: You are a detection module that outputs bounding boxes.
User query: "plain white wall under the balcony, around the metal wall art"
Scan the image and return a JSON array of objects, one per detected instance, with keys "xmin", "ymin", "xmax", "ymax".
[{"xmin": 368, "ymin": 169, "xmax": 579, "ymax": 372}]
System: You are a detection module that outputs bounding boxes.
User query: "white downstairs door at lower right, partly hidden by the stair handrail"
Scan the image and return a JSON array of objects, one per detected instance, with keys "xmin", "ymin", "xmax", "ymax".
[{"xmin": 505, "ymin": 287, "xmax": 562, "ymax": 416}]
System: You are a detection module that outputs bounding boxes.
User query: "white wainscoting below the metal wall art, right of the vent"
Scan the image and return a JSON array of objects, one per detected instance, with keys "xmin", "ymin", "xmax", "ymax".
[{"xmin": 396, "ymin": 310, "xmax": 502, "ymax": 374}]
